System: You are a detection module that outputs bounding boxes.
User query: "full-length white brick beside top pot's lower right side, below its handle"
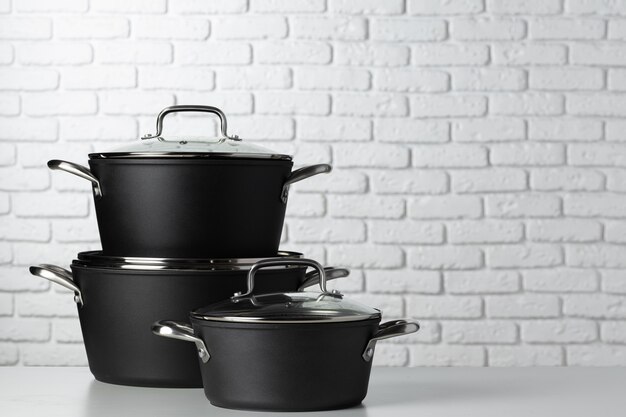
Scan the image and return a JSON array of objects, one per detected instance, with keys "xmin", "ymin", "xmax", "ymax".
[{"xmin": 289, "ymin": 219, "xmax": 366, "ymax": 243}]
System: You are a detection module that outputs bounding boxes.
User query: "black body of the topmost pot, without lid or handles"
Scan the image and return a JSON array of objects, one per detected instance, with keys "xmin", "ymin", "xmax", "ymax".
[{"xmin": 89, "ymin": 158, "xmax": 293, "ymax": 258}]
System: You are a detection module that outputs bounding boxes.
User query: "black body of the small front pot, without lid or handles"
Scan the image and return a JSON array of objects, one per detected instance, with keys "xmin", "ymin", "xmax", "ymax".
[{"xmin": 192, "ymin": 318, "xmax": 380, "ymax": 411}]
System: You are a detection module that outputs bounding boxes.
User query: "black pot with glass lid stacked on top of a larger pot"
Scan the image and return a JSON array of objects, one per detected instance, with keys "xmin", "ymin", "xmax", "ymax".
[{"xmin": 48, "ymin": 106, "xmax": 331, "ymax": 258}]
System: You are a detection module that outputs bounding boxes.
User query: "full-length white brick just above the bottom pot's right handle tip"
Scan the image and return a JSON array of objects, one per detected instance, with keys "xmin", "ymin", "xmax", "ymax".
[{"xmin": 328, "ymin": 245, "xmax": 404, "ymax": 269}]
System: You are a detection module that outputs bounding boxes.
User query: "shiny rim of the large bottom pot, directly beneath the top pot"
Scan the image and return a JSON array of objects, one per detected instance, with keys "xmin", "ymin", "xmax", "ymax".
[{"xmin": 72, "ymin": 251, "xmax": 303, "ymax": 271}]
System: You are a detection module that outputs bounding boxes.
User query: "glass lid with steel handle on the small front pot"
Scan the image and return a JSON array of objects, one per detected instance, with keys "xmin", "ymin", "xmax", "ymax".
[{"xmin": 191, "ymin": 259, "xmax": 381, "ymax": 324}]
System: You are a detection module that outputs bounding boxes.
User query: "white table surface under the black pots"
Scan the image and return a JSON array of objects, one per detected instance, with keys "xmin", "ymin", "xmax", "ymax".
[{"xmin": 0, "ymin": 368, "xmax": 626, "ymax": 417}]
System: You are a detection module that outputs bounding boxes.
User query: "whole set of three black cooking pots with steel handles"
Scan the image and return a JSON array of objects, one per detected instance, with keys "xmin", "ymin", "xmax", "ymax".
[{"xmin": 30, "ymin": 105, "xmax": 418, "ymax": 411}]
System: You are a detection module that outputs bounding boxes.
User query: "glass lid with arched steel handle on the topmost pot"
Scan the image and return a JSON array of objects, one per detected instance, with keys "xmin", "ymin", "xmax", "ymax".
[{"xmin": 89, "ymin": 105, "xmax": 292, "ymax": 161}]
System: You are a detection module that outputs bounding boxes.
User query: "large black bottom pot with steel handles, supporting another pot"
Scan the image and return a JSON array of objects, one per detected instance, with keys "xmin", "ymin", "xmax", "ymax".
[{"xmin": 30, "ymin": 252, "xmax": 348, "ymax": 388}]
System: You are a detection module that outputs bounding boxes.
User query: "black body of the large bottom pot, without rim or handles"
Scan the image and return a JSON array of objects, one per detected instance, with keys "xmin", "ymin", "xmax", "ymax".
[{"xmin": 72, "ymin": 265, "xmax": 306, "ymax": 388}]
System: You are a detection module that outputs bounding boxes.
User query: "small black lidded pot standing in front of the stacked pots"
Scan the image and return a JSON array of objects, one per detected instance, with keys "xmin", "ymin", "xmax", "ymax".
[{"xmin": 152, "ymin": 259, "xmax": 419, "ymax": 411}]
